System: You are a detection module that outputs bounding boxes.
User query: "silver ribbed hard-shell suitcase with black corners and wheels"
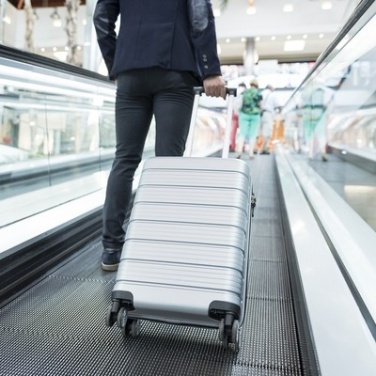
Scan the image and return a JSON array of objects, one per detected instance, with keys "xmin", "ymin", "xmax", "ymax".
[{"xmin": 106, "ymin": 89, "xmax": 253, "ymax": 350}]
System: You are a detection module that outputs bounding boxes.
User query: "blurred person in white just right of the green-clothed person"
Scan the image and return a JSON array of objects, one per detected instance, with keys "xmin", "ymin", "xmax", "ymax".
[{"xmin": 260, "ymin": 85, "xmax": 280, "ymax": 154}]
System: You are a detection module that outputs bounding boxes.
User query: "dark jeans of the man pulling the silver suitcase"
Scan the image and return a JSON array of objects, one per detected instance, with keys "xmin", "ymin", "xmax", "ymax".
[{"xmin": 102, "ymin": 68, "xmax": 199, "ymax": 248}]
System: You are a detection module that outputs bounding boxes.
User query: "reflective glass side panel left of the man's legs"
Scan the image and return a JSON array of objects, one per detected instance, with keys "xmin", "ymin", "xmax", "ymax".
[{"xmin": 0, "ymin": 58, "xmax": 115, "ymax": 209}]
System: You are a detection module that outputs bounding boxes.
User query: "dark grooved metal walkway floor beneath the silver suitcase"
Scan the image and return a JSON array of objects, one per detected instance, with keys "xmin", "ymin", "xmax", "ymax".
[{"xmin": 0, "ymin": 155, "xmax": 302, "ymax": 376}]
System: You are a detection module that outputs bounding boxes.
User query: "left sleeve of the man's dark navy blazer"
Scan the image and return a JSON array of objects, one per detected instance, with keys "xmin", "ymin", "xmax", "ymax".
[{"xmin": 93, "ymin": 0, "xmax": 120, "ymax": 74}]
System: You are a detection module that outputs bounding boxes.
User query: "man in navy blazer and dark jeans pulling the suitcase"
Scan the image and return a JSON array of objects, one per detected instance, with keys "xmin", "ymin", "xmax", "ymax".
[{"xmin": 93, "ymin": 0, "xmax": 226, "ymax": 271}]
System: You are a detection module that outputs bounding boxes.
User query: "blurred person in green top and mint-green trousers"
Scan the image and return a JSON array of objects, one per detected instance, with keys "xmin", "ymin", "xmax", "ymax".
[{"xmin": 236, "ymin": 80, "xmax": 262, "ymax": 159}]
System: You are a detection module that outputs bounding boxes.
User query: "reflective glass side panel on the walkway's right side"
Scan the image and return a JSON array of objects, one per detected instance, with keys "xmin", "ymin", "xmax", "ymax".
[{"xmin": 283, "ymin": 5, "xmax": 376, "ymax": 230}]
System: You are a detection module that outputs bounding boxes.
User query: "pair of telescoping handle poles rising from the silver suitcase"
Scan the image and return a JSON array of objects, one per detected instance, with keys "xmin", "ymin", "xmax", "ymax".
[{"xmin": 184, "ymin": 86, "xmax": 236, "ymax": 158}]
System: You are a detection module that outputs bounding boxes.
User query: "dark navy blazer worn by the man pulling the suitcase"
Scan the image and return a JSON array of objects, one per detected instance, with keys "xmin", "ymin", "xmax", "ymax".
[{"xmin": 93, "ymin": 0, "xmax": 221, "ymax": 79}]
